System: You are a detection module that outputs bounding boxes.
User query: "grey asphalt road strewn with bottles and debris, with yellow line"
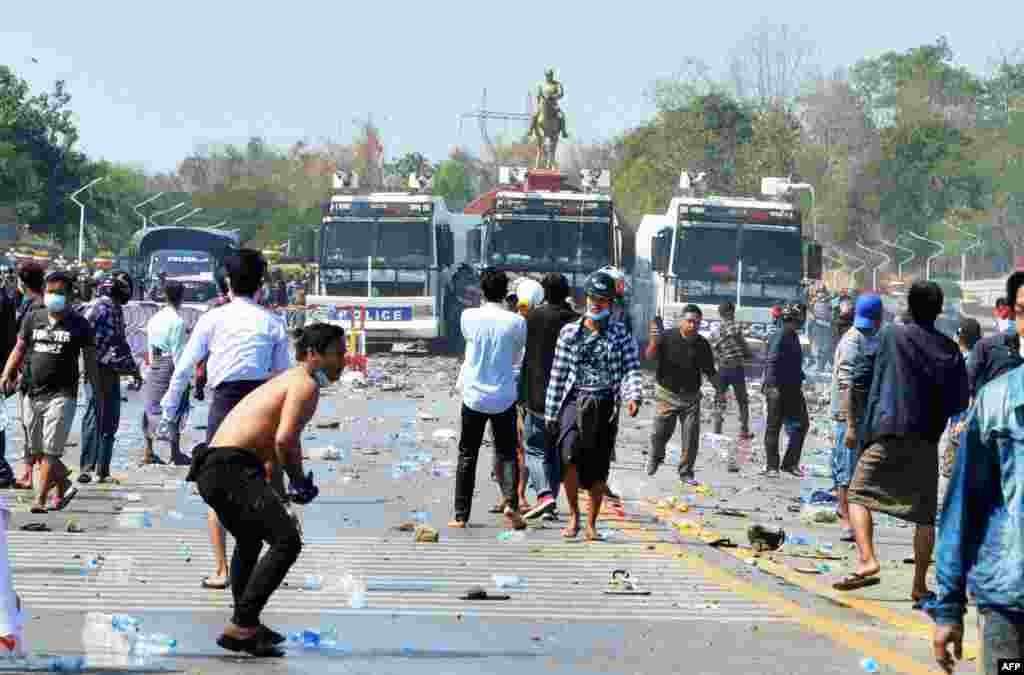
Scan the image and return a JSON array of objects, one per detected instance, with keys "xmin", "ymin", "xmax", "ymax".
[{"xmin": 6, "ymin": 356, "xmax": 954, "ymax": 675}]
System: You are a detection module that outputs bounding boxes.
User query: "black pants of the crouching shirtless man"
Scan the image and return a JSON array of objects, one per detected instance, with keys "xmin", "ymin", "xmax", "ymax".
[{"xmin": 193, "ymin": 448, "xmax": 302, "ymax": 628}]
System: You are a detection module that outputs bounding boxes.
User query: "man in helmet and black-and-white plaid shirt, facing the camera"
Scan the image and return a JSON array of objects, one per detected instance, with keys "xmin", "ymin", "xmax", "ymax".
[{"xmin": 544, "ymin": 271, "xmax": 643, "ymax": 541}]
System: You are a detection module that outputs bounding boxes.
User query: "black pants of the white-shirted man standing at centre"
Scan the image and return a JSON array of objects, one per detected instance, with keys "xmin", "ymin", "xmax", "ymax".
[{"xmin": 455, "ymin": 404, "xmax": 519, "ymax": 522}]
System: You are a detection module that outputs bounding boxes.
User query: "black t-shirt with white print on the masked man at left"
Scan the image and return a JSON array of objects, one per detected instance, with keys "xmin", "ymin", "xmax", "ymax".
[{"xmin": 20, "ymin": 307, "xmax": 95, "ymax": 396}]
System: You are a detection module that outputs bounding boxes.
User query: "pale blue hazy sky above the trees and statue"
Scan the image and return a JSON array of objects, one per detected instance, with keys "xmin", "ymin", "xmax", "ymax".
[{"xmin": 0, "ymin": 0, "xmax": 1024, "ymax": 171}]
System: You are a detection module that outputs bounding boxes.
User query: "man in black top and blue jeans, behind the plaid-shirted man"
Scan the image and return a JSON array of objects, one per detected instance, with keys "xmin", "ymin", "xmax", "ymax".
[{"xmin": 519, "ymin": 272, "xmax": 580, "ymax": 519}]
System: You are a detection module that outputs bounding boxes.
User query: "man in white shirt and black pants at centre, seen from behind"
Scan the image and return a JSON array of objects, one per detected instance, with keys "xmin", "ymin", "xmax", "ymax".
[{"xmin": 449, "ymin": 269, "xmax": 526, "ymax": 530}]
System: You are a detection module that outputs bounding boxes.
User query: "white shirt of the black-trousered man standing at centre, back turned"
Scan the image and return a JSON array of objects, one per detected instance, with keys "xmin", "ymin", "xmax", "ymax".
[{"xmin": 459, "ymin": 302, "xmax": 526, "ymax": 415}]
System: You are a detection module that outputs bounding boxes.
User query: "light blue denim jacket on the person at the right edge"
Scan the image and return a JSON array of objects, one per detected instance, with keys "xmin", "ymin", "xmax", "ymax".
[{"xmin": 928, "ymin": 369, "xmax": 1024, "ymax": 625}]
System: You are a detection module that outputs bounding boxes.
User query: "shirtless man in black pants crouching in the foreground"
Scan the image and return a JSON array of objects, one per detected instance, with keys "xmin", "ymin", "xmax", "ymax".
[{"xmin": 187, "ymin": 324, "xmax": 345, "ymax": 657}]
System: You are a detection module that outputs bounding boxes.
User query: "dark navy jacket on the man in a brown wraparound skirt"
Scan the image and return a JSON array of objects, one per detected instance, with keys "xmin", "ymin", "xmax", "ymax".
[{"xmin": 854, "ymin": 324, "xmax": 970, "ymax": 446}]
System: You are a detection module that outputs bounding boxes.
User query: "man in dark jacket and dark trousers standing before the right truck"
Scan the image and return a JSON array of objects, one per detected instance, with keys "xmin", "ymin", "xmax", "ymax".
[{"xmin": 764, "ymin": 304, "xmax": 810, "ymax": 478}]
